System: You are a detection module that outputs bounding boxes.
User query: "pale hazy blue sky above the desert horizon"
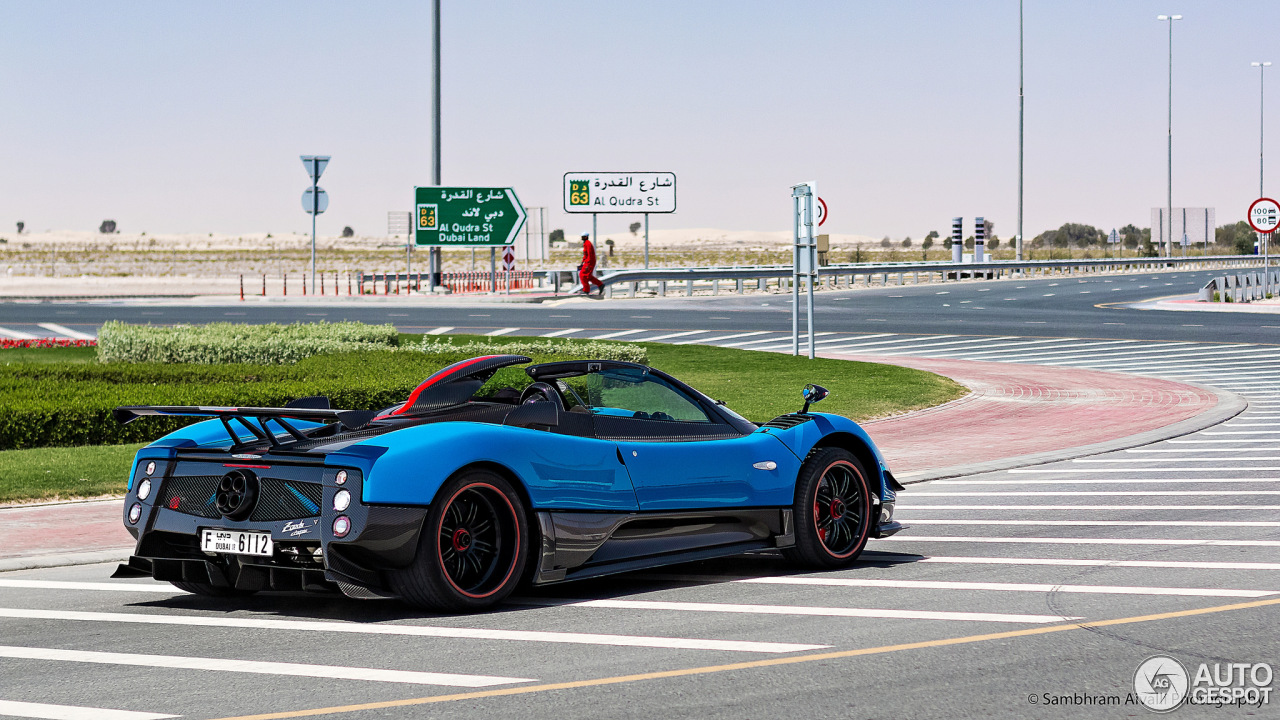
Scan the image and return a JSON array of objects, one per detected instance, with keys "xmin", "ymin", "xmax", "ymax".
[{"xmin": 0, "ymin": 0, "xmax": 1280, "ymax": 238}]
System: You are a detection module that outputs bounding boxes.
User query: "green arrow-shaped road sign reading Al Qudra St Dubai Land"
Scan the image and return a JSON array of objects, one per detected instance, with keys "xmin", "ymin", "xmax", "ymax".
[{"xmin": 413, "ymin": 186, "xmax": 525, "ymax": 247}]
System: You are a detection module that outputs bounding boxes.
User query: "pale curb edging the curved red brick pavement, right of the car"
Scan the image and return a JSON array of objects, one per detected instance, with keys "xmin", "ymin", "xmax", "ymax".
[{"xmin": 895, "ymin": 380, "xmax": 1249, "ymax": 486}]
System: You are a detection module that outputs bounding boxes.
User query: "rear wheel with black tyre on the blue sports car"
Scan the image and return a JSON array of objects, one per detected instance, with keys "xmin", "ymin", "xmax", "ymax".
[{"xmin": 392, "ymin": 470, "xmax": 530, "ymax": 612}]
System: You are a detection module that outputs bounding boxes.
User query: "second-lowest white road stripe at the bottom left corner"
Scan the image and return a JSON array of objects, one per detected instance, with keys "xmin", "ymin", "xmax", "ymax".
[{"xmin": 0, "ymin": 646, "xmax": 534, "ymax": 688}]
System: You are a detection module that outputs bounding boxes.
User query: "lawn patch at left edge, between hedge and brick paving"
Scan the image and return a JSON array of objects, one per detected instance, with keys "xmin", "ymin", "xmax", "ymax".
[{"xmin": 0, "ymin": 443, "xmax": 142, "ymax": 502}]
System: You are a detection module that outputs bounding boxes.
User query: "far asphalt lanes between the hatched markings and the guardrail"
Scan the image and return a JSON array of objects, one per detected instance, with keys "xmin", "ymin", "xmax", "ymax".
[{"xmin": 0, "ymin": 266, "xmax": 1280, "ymax": 343}]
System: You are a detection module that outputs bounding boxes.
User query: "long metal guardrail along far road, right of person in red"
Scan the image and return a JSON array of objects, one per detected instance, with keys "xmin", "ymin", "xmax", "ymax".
[{"xmin": 600, "ymin": 255, "xmax": 1262, "ymax": 297}]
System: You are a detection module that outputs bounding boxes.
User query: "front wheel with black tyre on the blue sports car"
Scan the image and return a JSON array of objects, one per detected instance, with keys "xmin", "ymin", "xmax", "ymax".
[{"xmin": 783, "ymin": 447, "xmax": 874, "ymax": 568}]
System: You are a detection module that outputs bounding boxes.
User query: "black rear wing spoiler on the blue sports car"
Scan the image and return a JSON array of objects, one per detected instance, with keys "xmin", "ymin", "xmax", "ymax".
[{"xmin": 111, "ymin": 397, "xmax": 378, "ymax": 447}]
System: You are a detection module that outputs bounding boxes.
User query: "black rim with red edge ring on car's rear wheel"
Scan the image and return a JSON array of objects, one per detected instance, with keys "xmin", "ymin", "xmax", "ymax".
[{"xmin": 435, "ymin": 483, "xmax": 524, "ymax": 600}]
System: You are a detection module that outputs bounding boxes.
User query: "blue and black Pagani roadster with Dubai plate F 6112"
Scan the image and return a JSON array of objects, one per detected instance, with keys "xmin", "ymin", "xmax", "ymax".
[{"xmin": 114, "ymin": 355, "xmax": 902, "ymax": 611}]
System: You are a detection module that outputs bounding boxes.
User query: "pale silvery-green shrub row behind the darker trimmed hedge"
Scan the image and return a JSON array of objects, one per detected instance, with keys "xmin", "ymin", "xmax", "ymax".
[{"xmin": 97, "ymin": 320, "xmax": 399, "ymax": 365}]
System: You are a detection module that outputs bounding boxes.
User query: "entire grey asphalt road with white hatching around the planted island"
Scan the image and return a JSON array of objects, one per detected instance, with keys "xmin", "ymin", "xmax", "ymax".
[{"xmin": 0, "ymin": 266, "xmax": 1280, "ymax": 720}]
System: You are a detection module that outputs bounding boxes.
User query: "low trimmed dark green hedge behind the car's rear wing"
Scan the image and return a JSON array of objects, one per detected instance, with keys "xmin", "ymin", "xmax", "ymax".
[{"xmin": 0, "ymin": 351, "xmax": 563, "ymax": 450}]
